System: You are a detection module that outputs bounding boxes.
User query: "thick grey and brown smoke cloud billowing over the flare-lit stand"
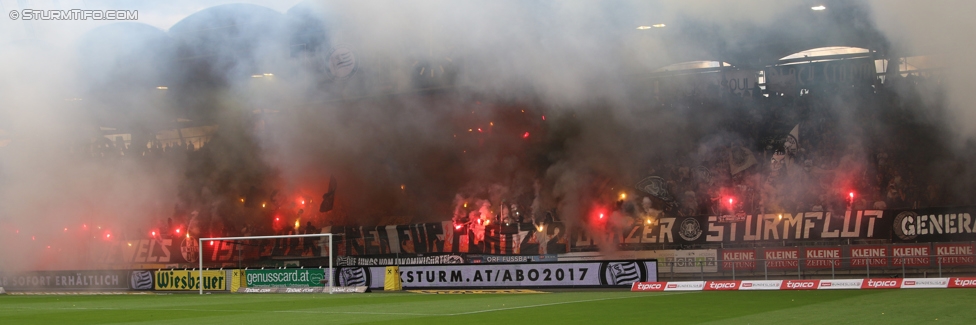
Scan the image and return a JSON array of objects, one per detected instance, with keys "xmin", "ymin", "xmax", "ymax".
[{"xmin": 0, "ymin": 1, "xmax": 976, "ymax": 269}]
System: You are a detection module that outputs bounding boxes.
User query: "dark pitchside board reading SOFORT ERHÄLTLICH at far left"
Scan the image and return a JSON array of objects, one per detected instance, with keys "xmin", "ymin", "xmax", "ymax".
[{"xmin": 0, "ymin": 270, "xmax": 132, "ymax": 291}]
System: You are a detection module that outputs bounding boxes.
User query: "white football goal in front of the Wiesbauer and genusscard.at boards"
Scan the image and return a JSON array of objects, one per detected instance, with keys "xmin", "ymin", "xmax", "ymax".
[{"xmin": 197, "ymin": 233, "xmax": 335, "ymax": 295}]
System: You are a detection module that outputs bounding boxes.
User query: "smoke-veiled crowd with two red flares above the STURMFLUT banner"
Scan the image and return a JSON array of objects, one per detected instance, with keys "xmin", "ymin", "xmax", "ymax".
[{"xmin": 651, "ymin": 76, "xmax": 962, "ymax": 216}]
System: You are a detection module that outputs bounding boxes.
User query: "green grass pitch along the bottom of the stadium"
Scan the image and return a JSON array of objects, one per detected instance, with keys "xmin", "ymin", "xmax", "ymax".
[{"xmin": 0, "ymin": 289, "xmax": 976, "ymax": 325}]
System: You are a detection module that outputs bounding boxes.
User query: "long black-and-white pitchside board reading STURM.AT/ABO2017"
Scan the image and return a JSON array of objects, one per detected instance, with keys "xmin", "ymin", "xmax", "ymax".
[{"xmin": 337, "ymin": 260, "xmax": 657, "ymax": 289}]
